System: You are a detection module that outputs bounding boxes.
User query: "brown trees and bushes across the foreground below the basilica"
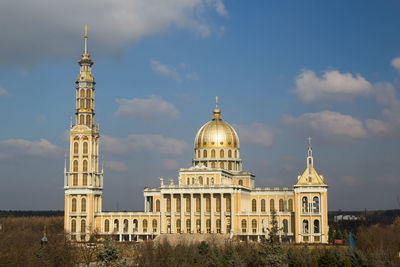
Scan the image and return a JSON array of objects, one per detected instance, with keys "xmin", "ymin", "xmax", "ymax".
[{"xmin": 0, "ymin": 217, "xmax": 400, "ymax": 267}]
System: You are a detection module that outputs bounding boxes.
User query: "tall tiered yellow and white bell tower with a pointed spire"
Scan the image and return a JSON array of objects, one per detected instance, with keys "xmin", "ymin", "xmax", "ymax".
[{"xmin": 64, "ymin": 26, "xmax": 103, "ymax": 241}]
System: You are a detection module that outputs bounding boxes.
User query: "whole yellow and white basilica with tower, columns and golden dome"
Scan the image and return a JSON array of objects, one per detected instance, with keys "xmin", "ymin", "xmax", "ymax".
[{"xmin": 64, "ymin": 27, "xmax": 328, "ymax": 243}]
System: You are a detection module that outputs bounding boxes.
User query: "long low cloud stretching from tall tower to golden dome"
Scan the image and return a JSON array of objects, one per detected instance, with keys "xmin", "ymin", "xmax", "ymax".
[{"xmin": 101, "ymin": 134, "xmax": 191, "ymax": 155}]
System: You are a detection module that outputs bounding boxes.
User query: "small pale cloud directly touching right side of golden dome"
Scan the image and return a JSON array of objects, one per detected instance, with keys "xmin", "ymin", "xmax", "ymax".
[{"xmin": 234, "ymin": 123, "xmax": 274, "ymax": 146}]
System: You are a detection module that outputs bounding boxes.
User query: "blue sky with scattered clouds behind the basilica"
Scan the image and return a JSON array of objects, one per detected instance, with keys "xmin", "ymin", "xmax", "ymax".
[{"xmin": 0, "ymin": 0, "xmax": 400, "ymax": 213}]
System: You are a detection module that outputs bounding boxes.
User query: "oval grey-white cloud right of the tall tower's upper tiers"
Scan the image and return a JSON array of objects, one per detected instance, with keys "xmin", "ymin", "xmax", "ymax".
[{"xmin": 115, "ymin": 95, "xmax": 179, "ymax": 123}]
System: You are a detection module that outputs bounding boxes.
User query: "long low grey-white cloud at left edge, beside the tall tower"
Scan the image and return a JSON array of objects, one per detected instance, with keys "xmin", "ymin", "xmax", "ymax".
[{"xmin": 0, "ymin": 138, "xmax": 62, "ymax": 159}]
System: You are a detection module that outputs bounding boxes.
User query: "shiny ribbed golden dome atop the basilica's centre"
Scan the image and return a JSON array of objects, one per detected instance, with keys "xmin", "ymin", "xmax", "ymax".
[{"xmin": 194, "ymin": 107, "xmax": 239, "ymax": 149}]
